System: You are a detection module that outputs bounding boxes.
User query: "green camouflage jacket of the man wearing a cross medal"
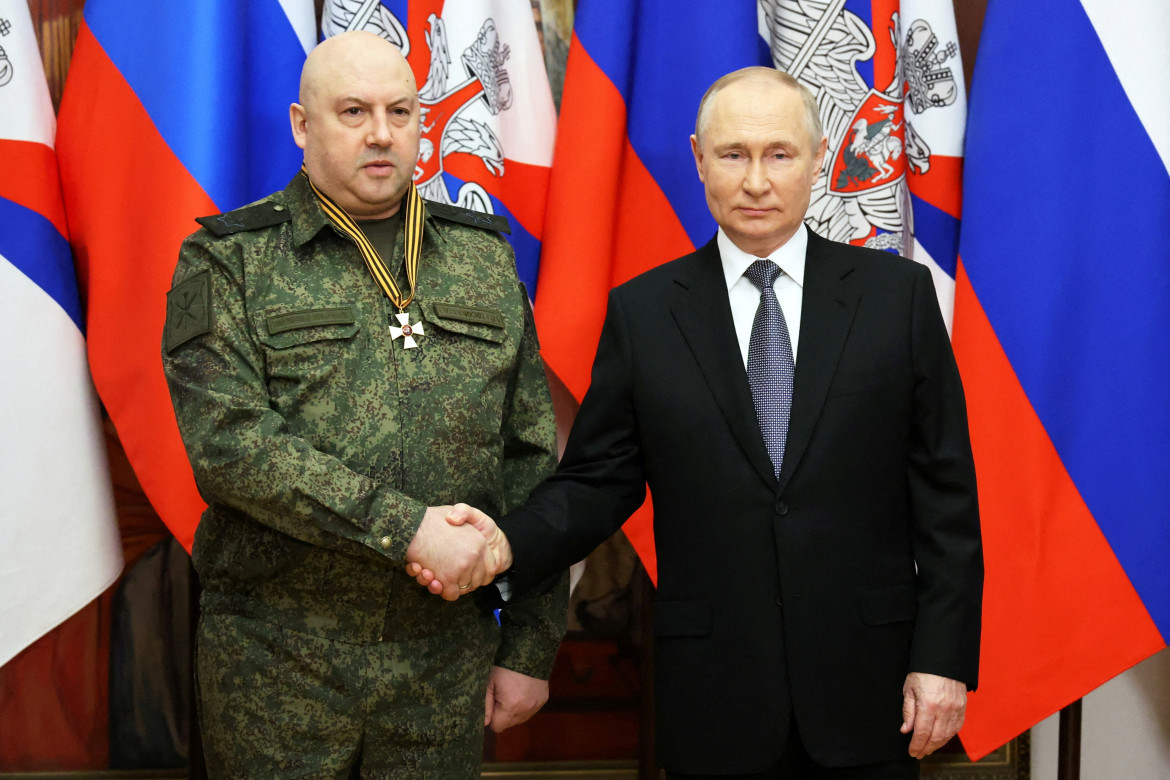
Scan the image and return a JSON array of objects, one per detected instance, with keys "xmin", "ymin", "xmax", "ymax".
[{"xmin": 163, "ymin": 175, "xmax": 567, "ymax": 677}]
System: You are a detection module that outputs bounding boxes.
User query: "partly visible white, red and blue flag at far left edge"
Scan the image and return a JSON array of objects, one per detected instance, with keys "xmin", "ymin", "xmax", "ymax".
[{"xmin": 0, "ymin": 0, "xmax": 122, "ymax": 665}]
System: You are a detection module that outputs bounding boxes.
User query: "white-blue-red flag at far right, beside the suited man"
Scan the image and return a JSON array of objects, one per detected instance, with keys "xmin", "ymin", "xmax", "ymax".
[{"xmin": 954, "ymin": 0, "xmax": 1170, "ymax": 755}]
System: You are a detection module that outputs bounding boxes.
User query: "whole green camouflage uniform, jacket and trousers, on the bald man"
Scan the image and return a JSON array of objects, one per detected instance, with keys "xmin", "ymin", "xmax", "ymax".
[{"xmin": 163, "ymin": 175, "xmax": 567, "ymax": 778}]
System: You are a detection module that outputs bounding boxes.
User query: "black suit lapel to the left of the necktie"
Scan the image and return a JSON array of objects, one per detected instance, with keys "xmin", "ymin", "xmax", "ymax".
[{"xmin": 670, "ymin": 239, "xmax": 776, "ymax": 485}]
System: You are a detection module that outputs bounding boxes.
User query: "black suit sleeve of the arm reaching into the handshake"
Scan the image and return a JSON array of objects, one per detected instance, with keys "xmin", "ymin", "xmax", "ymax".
[{"xmin": 500, "ymin": 290, "xmax": 646, "ymax": 593}]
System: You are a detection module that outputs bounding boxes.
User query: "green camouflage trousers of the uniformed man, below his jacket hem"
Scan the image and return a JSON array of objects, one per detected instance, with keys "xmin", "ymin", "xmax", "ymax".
[{"xmin": 195, "ymin": 613, "xmax": 494, "ymax": 780}]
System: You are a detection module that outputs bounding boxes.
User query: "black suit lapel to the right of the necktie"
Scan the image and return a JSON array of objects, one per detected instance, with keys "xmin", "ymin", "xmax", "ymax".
[{"xmin": 779, "ymin": 230, "xmax": 858, "ymax": 491}]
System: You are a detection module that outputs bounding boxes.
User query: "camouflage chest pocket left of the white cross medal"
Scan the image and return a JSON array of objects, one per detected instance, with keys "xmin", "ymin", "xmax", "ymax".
[{"xmin": 256, "ymin": 304, "xmax": 362, "ymax": 380}]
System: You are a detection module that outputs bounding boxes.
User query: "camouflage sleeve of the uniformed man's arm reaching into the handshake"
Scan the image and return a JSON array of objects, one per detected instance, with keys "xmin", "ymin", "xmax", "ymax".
[{"xmin": 163, "ymin": 233, "xmax": 426, "ymax": 564}]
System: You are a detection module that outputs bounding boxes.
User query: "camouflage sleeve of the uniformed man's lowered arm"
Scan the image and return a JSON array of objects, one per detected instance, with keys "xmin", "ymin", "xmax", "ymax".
[{"xmin": 495, "ymin": 279, "xmax": 569, "ymax": 679}]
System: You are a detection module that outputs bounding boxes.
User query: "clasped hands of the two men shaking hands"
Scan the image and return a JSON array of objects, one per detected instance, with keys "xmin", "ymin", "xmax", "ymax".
[{"xmin": 406, "ymin": 504, "xmax": 511, "ymax": 601}]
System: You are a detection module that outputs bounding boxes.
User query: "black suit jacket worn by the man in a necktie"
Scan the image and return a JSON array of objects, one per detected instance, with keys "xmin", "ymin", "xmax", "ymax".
[{"xmin": 501, "ymin": 232, "xmax": 983, "ymax": 773}]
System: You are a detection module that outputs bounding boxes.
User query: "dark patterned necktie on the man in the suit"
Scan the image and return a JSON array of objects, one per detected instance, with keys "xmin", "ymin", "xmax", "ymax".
[{"xmin": 743, "ymin": 260, "xmax": 796, "ymax": 477}]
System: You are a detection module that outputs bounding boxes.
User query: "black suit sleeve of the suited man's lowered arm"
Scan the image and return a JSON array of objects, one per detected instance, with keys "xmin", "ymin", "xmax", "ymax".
[{"xmin": 909, "ymin": 267, "xmax": 983, "ymax": 690}]
